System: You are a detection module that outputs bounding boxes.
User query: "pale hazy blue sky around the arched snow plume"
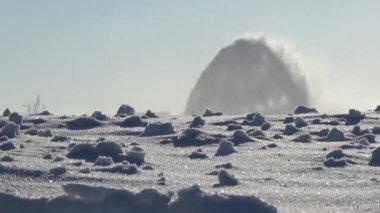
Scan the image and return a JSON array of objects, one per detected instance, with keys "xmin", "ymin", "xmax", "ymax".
[{"xmin": 0, "ymin": 0, "xmax": 380, "ymax": 114}]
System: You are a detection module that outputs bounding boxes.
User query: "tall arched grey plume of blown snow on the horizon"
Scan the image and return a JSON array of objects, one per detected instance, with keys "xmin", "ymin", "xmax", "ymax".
[{"xmin": 185, "ymin": 36, "xmax": 309, "ymax": 114}]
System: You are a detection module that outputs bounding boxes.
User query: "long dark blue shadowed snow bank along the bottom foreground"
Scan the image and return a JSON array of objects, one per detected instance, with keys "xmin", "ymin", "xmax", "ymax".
[{"xmin": 0, "ymin": 184, "xmax": 277, "ymax": 213}]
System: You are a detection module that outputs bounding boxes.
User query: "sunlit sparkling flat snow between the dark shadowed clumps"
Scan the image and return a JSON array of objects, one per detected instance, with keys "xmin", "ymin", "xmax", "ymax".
[{"xmin": 0, "ymin": 111, "xmax": 380, "ymax": 212}]
